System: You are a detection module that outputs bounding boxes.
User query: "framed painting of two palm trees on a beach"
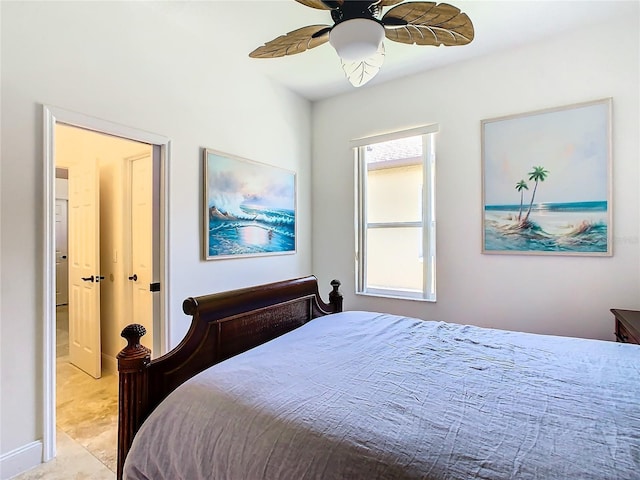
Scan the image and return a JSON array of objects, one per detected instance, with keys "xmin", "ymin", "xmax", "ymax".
[{"xmin": 481, "ymin": 98, "xmax": 612, "ymax": 256}]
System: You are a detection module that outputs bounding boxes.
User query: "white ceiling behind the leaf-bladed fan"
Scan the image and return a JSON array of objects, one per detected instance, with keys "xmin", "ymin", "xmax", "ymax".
[{"xmin": 146, "ymin": 0, "xmax": 639, "ymax": 100}]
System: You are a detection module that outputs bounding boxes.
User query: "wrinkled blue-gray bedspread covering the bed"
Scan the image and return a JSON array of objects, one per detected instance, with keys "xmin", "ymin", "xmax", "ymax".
[{"xmin": 125, "ymin": 312, "xmax": 640, "ymax": 480}]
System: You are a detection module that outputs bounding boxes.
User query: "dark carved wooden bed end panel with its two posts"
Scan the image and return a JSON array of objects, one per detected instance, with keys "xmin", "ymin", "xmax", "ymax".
[{"xmin": 117, "ymin": 276, "xmax": 342, "ymax": 480}]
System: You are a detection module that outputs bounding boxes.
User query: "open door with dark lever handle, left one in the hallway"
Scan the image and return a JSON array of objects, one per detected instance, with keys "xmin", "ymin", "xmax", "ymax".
[{"xmin": 68, "ymin": 159, "xmax": 101, "ymax": 378}]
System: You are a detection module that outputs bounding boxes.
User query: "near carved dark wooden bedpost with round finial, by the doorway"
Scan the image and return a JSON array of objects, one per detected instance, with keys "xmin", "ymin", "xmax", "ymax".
[{"xmin": 117, "ymin": 324, "xmax": 151, "ymax": 480}]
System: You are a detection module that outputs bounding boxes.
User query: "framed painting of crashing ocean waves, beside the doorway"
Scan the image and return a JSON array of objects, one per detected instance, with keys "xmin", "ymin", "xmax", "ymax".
[{"xmin": 204, "ymin": 149, "xmax": 296, "ymax": 260}]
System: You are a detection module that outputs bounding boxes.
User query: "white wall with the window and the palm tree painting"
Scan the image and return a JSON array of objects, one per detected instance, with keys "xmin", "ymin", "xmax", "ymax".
[{"xmin": 312, "ymin": 15, "xmax": 640, "ymax": 339}]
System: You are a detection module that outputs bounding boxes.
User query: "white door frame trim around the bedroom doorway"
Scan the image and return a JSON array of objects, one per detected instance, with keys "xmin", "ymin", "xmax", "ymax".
[{"xmin": 42, "ymin": 104, "xmax": 171, "ymax": 462}]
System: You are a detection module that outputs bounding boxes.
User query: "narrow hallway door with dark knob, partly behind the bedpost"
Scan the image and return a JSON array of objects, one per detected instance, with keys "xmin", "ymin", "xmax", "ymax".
[{"xmin": 129, "ymin": 155, "xmax": 154, "ymax": 357}]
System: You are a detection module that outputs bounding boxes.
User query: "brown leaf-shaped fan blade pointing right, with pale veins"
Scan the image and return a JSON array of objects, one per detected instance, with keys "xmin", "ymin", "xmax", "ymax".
[{"xmin": 382, "ymin": 2, "xmax": 474, "ymax": 46}]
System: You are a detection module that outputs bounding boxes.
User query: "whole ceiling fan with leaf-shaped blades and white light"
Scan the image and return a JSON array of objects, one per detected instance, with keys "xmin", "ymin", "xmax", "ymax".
[{"xmin": 249, "ymin": 0, "xmax": 474, "ymax": 87}]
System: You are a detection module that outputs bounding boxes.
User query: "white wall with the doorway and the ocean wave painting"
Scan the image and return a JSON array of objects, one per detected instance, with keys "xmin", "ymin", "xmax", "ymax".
[{"xmin": 0, "ymin": 2, "xmax": 311, "ymax": 472}]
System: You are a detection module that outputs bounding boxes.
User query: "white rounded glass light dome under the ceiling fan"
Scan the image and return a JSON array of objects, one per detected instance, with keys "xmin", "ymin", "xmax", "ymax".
[{"xmin": 329, "ymin": 18, "xmax": 384, "ymax": 62}]
